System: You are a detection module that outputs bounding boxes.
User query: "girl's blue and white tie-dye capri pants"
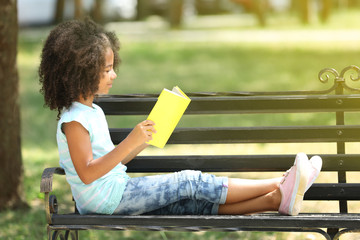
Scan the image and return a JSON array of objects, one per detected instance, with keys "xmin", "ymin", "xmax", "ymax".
[{"xmin": 114, "ymin": 170, "xmax": 228, "ymax": 215}]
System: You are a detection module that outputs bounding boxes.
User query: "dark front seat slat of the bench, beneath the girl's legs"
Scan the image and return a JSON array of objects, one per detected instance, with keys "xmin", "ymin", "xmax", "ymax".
[{"xmin": 52, "ymin": 213, "xmax": 360, "ymax": 230}]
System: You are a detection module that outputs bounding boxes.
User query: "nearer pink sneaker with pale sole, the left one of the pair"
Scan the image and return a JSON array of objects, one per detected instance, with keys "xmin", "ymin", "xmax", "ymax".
[{"xmin": 279, "ymin": 153, "xmax": 310, "ymax": 216}]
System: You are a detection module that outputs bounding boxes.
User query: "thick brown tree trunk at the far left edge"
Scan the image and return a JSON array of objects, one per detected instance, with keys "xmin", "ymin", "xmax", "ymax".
[{"xmin": 0, "ymin": 0, "xmax": 26, "ymax": 210}]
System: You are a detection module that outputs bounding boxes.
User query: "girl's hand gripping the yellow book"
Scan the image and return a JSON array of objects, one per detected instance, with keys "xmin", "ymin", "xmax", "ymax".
[{"xmin": 128, "ymin": 120, "xmax": 156, "ymax": 146}]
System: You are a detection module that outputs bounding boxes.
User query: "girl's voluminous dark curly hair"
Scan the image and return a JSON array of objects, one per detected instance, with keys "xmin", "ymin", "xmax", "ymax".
[{"xmin": 39, "ymin": 19, "xmax": 120, "ymax": 119}]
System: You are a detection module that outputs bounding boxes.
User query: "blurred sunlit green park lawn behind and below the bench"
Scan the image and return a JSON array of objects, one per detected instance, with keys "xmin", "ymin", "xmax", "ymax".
[{"xmin": 0, "ymin": 0, "xmax": 360, "ymax": 239}]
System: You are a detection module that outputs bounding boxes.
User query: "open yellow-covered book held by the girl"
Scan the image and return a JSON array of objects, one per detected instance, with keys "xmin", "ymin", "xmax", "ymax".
[{"xmin": 147, "ymin": 86, "xmax": 191, "ymax": 148}]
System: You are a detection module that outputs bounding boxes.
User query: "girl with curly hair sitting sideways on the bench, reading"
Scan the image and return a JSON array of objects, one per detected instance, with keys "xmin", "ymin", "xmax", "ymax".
[{"xmin": 39, "ymin": 20, "xmax": 322, "ymax": 215}]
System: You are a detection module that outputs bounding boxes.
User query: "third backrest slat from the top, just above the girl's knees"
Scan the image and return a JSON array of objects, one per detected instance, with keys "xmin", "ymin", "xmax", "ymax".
[{"xmin": 127, "ymin": 154, "xmax": 360, "ymax": 173}]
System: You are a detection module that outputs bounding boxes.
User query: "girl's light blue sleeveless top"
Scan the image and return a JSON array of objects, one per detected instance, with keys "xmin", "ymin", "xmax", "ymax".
[{"xmin": 56, "ymin": 102, "xmax": 129, "ymax": 214}]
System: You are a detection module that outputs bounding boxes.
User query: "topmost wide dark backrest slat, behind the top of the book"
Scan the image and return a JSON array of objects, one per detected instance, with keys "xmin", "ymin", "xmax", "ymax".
[{"xmin": 95, "ymin": 95, "xmax": 360, "ymax": 115}]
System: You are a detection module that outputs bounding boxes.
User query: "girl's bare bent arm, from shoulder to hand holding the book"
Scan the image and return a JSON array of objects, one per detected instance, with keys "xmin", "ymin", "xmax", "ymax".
[{"xmin": 63, "ymin": 120, "xmax": 156, "ymax": 184}]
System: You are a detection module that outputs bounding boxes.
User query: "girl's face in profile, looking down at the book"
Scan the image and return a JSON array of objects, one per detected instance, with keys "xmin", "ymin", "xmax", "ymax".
[{"xmin": 97, "ymin": 48, "xmax": 116, "ymax": 94}]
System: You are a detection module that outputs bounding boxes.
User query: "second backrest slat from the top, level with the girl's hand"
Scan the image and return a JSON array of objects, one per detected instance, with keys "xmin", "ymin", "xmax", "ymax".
[{"xmin": 110, "ymin": 125, "xmax": 360, "ymax": 144}]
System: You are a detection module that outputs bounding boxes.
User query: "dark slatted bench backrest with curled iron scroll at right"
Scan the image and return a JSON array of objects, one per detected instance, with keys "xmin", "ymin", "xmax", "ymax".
[{"xmin": 97, "ymin": 66, "xmax": 360, "ymax": 212}]
